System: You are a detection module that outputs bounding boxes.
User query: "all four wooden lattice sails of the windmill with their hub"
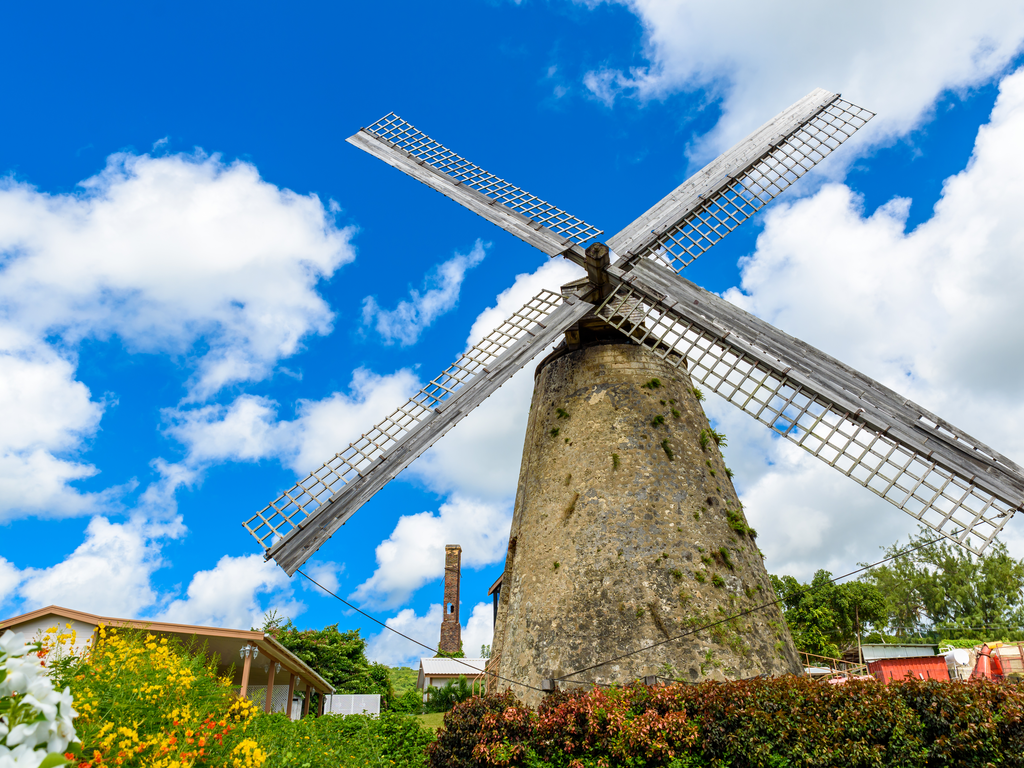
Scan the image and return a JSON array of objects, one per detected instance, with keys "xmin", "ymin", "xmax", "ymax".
[{"xmin": 244, "ymin": 88, "xmax": 1024, "ymax": 573}]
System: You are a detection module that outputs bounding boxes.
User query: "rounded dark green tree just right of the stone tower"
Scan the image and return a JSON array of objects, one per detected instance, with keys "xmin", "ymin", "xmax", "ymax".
[{"xmin": 771, "ymin": 570, "xmax": 887, "ymax": 658}]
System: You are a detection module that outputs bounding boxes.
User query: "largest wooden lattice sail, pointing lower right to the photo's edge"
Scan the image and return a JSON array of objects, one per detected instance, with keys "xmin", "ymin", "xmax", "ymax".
[{"xmin": 597, "ymin": 260, "xmax": 1024, "ymax": 554}]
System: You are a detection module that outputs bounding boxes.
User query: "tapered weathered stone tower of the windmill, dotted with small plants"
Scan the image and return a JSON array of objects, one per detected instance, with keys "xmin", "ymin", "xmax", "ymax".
[{"xmin": 492, "ymin": 344, "xmax": 800, "ymax": 703}]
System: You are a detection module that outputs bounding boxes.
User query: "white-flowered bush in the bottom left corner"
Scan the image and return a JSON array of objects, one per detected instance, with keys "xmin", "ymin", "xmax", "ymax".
[{"xmin": 0, "ymin": 631, "xmax": 76, "ymax": 768}]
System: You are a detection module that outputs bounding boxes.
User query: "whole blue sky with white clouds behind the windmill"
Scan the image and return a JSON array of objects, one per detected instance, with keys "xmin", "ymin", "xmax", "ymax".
[{"xmin": 0, "ymin": 0, "xmax": 1024, "ymax": 664}]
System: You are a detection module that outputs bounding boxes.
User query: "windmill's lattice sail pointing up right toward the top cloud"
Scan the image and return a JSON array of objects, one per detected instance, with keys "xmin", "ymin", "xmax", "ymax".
[{"xmin": 607, "ymin": 88, "xmax": 874, "ymax": 273}]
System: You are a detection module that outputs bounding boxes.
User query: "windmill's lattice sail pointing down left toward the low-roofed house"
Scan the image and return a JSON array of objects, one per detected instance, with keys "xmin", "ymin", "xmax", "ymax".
[{"xmin": 244, "ymin": 291, "xmax": 593, "ymax": 575}]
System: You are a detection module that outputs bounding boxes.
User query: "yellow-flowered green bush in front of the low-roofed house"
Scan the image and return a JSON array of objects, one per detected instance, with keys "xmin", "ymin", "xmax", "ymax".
[{"xmin": 48, "ymin": 627, "xmax": 266, "ymax": 768}]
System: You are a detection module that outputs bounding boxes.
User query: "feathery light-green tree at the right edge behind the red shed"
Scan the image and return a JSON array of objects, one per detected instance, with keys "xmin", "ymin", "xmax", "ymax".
[{"xmin": 864, "ymin": 528, "xmax": 1024, "ymax": 639}]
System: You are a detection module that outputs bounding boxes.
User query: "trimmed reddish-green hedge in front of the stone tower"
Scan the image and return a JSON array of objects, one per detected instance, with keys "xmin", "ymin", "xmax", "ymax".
[{"xmin": 427, "ymin": 677, "xmax": 1024, "ymax": 768}]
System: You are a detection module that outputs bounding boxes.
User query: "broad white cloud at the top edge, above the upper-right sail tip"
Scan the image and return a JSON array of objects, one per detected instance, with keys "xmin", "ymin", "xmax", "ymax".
[{"xmin": 578, "ymin": 0, "xmax": 1024, "ymax": 156}]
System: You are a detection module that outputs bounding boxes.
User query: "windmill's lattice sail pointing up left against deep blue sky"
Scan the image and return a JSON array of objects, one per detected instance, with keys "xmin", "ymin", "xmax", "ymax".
[{"xmin": 347, "ymin": 113, "xmax": 603, "ymax": 264}]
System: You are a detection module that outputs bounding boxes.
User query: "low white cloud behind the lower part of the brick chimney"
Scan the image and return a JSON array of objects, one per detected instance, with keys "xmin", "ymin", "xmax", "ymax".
[{"xmin": 367, "ymin": 603, "xmax": 494, "ymax": 669}]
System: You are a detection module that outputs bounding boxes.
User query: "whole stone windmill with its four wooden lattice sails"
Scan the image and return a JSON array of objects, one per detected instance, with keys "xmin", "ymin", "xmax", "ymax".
[{"xmin": 245, "ymin": 89, "xmax": 1024, "ymax": 704}]
